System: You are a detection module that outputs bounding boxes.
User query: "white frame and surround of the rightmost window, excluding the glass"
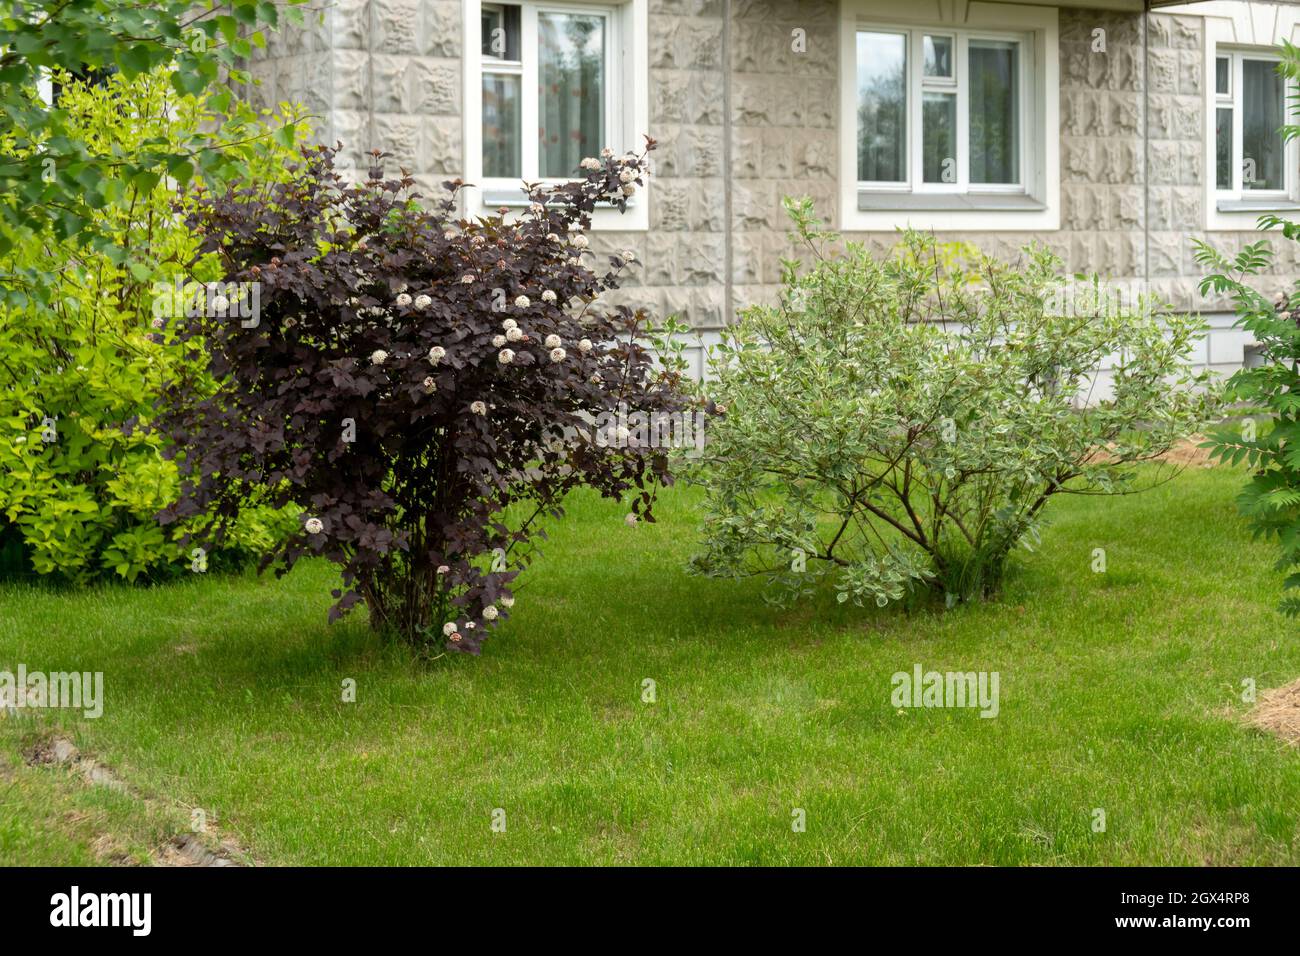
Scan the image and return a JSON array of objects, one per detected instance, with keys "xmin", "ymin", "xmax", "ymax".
[{"xmin": 1190, "ymin": 0, "xmax": 1300, "ymax": 232}]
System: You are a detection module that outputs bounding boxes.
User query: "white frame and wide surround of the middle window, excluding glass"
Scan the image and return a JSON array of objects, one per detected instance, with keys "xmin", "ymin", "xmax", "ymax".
[{"xmin": 840, "ymin": 0, "xmax": 1061, "ymax": 232}]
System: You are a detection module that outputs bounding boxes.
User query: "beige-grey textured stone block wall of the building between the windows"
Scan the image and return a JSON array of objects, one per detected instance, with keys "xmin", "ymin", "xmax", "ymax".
[{"xmin": 245, "ymin": 0, "xmax": 1300, "ymax": 377}]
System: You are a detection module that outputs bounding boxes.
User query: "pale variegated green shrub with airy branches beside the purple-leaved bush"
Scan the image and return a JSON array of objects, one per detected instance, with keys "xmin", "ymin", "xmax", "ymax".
[{"xmin": 693, "ymin": 200, "xmax": 1216, "ymax": 606}]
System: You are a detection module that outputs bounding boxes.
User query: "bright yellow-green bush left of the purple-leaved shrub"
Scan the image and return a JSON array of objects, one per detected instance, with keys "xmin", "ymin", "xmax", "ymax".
[{"xmin": 0, "ymin": 69, "xmax": 302, "ymax": 581}]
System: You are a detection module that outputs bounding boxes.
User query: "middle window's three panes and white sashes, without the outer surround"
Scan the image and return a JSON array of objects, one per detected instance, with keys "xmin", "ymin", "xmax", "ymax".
[{"xmin": 857, "ymin": 29, "xmax": 1028, "ymax": 193}]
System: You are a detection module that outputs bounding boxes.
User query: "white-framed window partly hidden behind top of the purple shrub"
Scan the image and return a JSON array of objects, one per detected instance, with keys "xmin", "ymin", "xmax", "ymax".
[{"xmin": 465, "ymin": 0, "xmax": 649, "ymax": 229}]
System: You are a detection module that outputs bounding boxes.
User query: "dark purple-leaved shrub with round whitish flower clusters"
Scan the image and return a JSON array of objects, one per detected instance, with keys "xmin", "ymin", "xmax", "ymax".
[{"xmin": 160, "ymin": 140, "xmax": 686, "ymax": 652}]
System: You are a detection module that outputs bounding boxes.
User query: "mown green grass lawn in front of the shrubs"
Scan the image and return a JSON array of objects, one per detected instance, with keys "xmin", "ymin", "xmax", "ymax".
[{"xmin": 0, "ymin": 468, "xmax": 1300, "ymax": 865}]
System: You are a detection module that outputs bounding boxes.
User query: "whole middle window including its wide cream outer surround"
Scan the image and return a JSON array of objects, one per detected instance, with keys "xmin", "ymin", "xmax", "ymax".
[{"xmin": 841, "ymin": 0, "xmax": 1060, "ymax": 230}]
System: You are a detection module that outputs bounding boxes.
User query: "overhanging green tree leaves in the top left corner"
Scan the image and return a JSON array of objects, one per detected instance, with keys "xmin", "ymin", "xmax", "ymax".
[{"xmin": 0, "ymin": 0, "xmax": 303, "ymax": 299}]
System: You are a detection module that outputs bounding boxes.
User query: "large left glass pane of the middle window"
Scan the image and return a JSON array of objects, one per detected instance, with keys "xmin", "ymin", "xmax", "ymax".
[{"xmin": 858, "ymin": 33, "xmax": 907, "ymax": 182}]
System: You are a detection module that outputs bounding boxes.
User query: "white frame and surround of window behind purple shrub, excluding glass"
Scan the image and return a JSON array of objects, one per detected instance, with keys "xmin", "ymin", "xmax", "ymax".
[{"xmin": 463, "ymin": 0, "xmax": 653, "ymax": 232}]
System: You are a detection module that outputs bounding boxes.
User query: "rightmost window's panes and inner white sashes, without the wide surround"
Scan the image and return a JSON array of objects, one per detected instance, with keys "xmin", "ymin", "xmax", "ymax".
[{"xmin": 1214, "ymin": 51, "xmax": 1295, "ymax": 200}]
